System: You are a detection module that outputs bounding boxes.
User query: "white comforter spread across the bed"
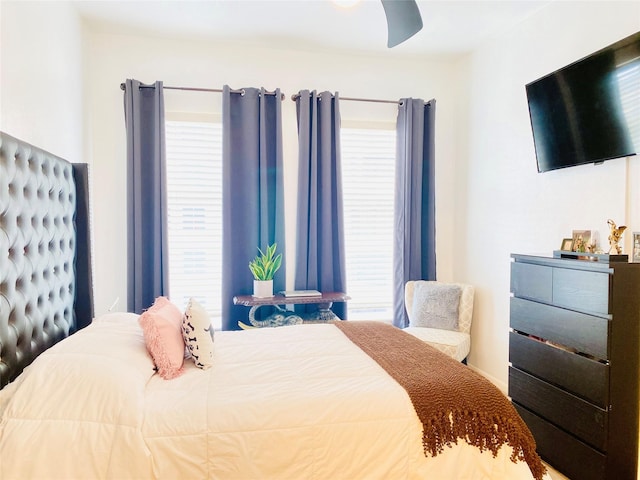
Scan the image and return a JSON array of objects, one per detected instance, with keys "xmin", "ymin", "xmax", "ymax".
[{"xmin": 0, "ymin": 313, "xmax": 544, "ymax": 480}]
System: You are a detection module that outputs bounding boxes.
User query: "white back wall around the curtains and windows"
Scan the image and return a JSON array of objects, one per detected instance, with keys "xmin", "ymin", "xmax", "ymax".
[{"xmin": 86, "ymin": 31, "xmax": 464, "ymax": 313}]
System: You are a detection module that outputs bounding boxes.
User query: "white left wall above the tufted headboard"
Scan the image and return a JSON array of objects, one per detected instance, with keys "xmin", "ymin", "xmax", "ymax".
[{"xmin": 0, "ymin": 0, "xmax": 85, "ymax": 162}]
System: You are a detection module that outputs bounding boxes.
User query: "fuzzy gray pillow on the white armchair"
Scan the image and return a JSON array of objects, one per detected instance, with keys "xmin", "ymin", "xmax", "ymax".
[{"xmin": 409, "ymin": 282, "xmax": 462, "ymax": 330}]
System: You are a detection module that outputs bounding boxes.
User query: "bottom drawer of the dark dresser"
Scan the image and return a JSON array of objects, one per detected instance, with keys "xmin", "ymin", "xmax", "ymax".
[{"xmin": 514, "ymin": 403, "xmax": 606, "ymax": 480}]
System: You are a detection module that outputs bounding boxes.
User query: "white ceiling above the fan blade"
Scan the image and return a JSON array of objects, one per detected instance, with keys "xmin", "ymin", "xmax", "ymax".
[{"xmin": 72, "ymin": 0, "xmax": 554, "ymax": 55}]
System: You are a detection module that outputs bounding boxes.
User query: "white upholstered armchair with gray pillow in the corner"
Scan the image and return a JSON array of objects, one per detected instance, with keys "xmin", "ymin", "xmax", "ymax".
[{"xmin": 404, "ymin": 280, "xmax": 474, "ymax": 363}]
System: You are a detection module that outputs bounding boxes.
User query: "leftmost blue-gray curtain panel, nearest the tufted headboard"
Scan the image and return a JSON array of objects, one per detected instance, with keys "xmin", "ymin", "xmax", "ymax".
[{"xmin": 124, "ymin": 80, "xmax": 169, "ymax": 313}]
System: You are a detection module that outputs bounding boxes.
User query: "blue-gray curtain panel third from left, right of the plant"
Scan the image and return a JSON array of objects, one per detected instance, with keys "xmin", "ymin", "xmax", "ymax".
[{"xmin": 295, "ymin": 90, "xmax": 346, "ymax": 319}]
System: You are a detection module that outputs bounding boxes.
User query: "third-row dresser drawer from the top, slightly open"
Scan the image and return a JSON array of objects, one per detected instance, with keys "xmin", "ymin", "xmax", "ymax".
[{"xmin": 509, "ymin": 332, "xmax": 609, "ymax": 409}]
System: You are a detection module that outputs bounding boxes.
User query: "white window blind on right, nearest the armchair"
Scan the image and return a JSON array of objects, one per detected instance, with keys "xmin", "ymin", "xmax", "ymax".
[{"xmin": 340, "ymin": 128, "xmax": 396, "ymax": 322}]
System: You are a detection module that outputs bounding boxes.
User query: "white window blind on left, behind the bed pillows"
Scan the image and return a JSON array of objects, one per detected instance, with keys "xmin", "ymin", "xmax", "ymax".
[{"xmin": 165, "ymin": 120, "xmax": 222, "ymax": 329}]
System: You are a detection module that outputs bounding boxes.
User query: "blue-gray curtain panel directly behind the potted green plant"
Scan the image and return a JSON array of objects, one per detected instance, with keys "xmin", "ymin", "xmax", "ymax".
[{"xmin": 222, "ymin": 85, "xmax": 286, "ymax": 330}]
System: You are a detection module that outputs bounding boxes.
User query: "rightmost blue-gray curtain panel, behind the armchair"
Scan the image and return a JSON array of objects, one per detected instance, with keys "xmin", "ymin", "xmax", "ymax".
[{"xmin": 393, "ymin": 98, "xmax": 436, "ymax": 328}]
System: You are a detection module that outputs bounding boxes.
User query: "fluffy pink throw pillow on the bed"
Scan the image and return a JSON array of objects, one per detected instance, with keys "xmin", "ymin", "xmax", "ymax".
[{"xmin": 138, "ymin": 297, "xmax": 184, "ymax": 380}]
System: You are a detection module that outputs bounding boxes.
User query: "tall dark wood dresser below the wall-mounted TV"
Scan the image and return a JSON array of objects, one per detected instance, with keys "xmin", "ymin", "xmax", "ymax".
[{"xmin": 509, "ymin": 254, "xmax": 640, "ymax": 480}]
